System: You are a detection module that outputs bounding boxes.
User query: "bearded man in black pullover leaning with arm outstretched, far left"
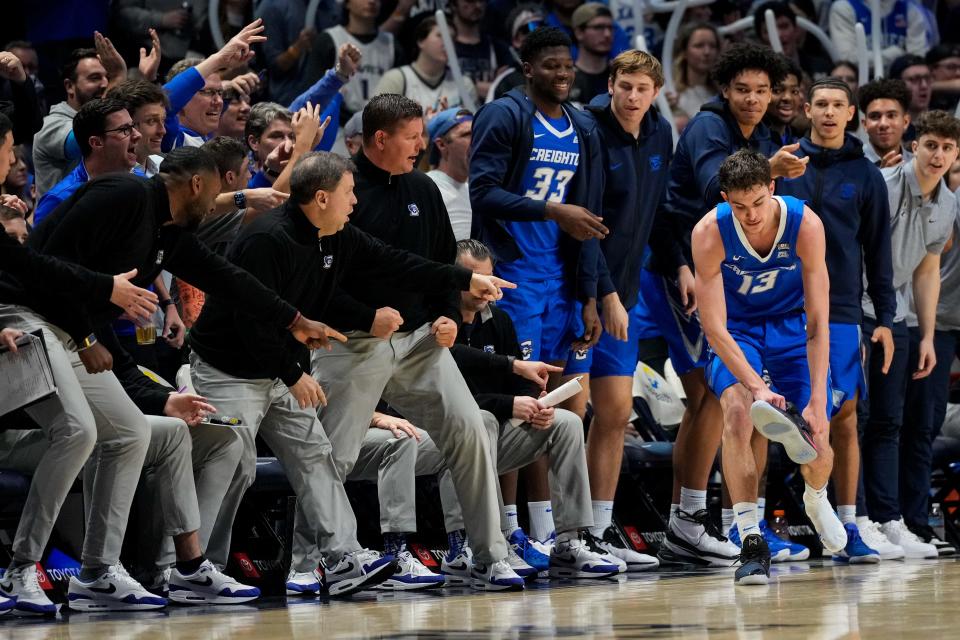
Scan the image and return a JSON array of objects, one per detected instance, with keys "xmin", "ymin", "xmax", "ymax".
[{"xmin": 0, "ymin": 144, "xmax": 338, "ymax": 613}]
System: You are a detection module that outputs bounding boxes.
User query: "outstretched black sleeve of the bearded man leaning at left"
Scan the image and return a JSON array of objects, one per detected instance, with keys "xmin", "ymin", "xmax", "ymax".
[{"xmin": 165, "ymin": 232, "xmax": 297, "ymax": 328}]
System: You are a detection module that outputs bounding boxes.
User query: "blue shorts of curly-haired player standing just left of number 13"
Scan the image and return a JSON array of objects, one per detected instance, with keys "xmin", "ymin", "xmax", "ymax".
[{"xmin": 640, "ymin": 269, "xmax": 707, "ymax": 376}]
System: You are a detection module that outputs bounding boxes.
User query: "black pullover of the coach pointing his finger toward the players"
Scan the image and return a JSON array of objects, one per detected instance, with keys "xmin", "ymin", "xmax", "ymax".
[{"xmin": 190, "ymin": 201, "xmax": 472, "ymax": 386}]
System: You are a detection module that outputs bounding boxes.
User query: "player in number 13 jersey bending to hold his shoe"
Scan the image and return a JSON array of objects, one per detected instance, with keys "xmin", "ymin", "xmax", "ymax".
[{"xmin": 691, "ymin": 150, "xmax": 847, "ymax": 584}]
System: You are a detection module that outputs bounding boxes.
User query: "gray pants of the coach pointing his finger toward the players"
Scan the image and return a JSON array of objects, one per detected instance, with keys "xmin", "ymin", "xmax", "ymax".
[{"xmin": 190, "ymin": 353, "xmax": 362, "ymax": 572}]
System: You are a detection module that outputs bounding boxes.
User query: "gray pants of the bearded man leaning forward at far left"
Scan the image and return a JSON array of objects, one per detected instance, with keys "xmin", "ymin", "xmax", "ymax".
[{"xmin": 0, "ymin": 305, "xmax": 150, "ymax": 567}]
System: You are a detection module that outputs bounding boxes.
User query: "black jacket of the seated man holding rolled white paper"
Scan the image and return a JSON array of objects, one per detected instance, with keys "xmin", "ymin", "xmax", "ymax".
[{"xmin": 450, "ymin": 305, "xmax": 540, "ymax": 423}]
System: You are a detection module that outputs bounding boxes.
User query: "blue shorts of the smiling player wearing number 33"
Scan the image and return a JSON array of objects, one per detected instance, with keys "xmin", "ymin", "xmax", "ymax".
[{"xmin": 497, "ymin": 279, "xmax": 583, "ymax": 362}]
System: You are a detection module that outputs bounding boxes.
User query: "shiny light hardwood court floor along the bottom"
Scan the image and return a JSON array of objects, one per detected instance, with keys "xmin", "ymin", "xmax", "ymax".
[{"xmin": 0, "ymin": 560, "xmax": 960, "ymax": 640}]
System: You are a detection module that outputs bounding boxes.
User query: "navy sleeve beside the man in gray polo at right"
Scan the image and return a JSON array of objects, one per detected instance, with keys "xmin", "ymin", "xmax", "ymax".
[{"xmin": 859, "ymin": 170, "xmax": 897, "ymax": 327}]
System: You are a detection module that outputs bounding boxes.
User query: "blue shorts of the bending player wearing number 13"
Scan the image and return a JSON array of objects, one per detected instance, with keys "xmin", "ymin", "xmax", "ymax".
[{"xmin": 706, "ymin": 313, "xmax": 839, "ymax": 418}]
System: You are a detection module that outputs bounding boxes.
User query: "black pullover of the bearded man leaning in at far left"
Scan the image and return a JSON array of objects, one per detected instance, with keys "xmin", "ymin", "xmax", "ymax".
[{"xmin": 0, "ymin": 174, "xmax": 297, "ymax": 341}]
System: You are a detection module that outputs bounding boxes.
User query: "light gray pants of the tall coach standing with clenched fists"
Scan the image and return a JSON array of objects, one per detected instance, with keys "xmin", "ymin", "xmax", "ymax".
[{"xmin": 310, "ymin": 325, "xmax": 507, "ymax": 563}]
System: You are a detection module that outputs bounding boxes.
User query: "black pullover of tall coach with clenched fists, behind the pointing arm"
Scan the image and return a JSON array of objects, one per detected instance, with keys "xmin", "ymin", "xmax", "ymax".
[{"xmin": 326, "ymin": 149, "xmax": 460, "ymax": 331}]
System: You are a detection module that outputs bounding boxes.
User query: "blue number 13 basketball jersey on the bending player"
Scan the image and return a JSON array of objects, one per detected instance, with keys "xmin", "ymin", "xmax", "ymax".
[{"xmin": 717, "ymin": 196, "xmax": 803, "ymax": 321}]
